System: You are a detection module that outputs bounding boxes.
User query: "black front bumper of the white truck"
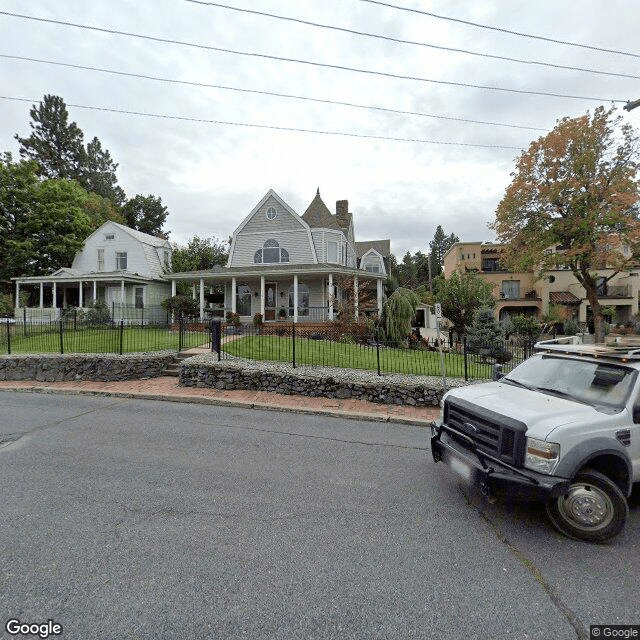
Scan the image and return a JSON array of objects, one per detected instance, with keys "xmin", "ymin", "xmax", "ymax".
[{"xmin": 431, "ymin": 426, "xmax": 569, "ymax": 502}]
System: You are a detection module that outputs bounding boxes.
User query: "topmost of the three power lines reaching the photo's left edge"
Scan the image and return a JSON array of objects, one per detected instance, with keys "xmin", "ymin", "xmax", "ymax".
[{"xmin": 0, "ymin": 11, "xmax": 626, "ymax": 103}]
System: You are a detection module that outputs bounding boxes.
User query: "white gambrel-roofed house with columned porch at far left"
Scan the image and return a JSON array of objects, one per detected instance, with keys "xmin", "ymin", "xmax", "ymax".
[{"xmin": 12, "ymin": 221, "xmax": 171, "ymax": 320}]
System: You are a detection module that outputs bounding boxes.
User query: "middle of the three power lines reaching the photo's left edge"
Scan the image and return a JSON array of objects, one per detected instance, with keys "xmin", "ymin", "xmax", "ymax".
[{"xmin": 0, "ymin": 53, "xmax": 548, "ymax": 131}]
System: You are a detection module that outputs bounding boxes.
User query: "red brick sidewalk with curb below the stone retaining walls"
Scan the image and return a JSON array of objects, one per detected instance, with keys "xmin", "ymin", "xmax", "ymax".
[{"xmin": 0, "ymin": 377, "xmax": 440, "ymax": 427}]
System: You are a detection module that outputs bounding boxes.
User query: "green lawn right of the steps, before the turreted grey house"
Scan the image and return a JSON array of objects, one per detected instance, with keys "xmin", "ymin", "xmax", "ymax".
[{"xmin": 223, "ymin": 336, "xmax": 500, "ymax": 378}]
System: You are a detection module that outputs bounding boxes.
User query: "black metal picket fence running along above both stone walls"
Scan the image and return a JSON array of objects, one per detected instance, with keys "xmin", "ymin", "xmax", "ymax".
[{"xmin": 0, "ymin": 308, "xmax": 533, "ymax": 380}]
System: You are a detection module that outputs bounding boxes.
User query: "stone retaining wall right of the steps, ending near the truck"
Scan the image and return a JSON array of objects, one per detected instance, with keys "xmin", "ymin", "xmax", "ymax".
[{"xmin": 180, "ymin": 357, "xmax": 444, "ymax": 407}]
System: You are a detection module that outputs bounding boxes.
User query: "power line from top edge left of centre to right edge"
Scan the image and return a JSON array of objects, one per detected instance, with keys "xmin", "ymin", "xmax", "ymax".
[{"xmin": 185, "ymin": 0, "xmax": 640, "ymax": 80}]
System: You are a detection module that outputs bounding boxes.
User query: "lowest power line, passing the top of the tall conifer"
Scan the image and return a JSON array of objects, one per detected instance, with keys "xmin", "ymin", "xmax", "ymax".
[{"xmin": 0, "ymin": 96, "xmax": 522, "ymax": 151}]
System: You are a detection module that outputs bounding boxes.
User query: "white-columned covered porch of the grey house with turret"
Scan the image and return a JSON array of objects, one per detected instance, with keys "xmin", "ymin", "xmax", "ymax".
[{"xmin": 165, "ymin": 265, "xmax": 386, "ymax": 323}]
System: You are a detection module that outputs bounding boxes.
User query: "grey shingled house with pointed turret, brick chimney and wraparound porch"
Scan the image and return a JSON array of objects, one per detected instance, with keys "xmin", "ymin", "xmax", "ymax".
[{"xmin": 165, "ymin": 190, "xmax": 390, "ymax": 322}]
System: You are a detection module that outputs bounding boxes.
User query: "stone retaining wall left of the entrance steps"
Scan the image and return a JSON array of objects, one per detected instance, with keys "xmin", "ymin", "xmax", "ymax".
[{"xmin": 0, "ymin": 351, "xmax": 175, "ymax": 382}]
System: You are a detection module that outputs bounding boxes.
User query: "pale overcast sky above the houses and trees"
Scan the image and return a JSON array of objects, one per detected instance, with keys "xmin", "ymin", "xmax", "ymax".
[{"xmin": 0, "ymin": 0, "xmax": 640, "ymax": 257}]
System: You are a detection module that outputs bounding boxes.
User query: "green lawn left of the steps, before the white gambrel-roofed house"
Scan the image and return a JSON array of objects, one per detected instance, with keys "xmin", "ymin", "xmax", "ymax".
[{"xmin": 0, "ymin": 325, "xmax": 209, "ymax": 353}]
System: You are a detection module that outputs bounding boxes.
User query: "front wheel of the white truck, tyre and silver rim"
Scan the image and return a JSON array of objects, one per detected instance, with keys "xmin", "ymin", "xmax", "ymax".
[{"xmin": 547, "ymin": 469, "xmax": 629, "ymax": 542}]
